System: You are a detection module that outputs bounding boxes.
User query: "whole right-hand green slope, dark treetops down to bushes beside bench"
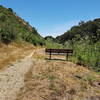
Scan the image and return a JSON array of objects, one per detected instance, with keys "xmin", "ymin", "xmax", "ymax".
[{"xmin": 55, "ymin": 18, "xmax": 100, "ymax": 71}]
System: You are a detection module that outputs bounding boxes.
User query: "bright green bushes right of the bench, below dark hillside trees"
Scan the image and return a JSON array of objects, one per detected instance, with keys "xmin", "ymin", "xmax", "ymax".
[{"xmin": 65, "ymin": 40, "xmax": 100, "ymax": 71}]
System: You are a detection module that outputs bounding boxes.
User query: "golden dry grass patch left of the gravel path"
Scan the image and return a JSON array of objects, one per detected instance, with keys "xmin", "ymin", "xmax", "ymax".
[{"xmin": 0, "ymin": 43, "xmax": 35, "ymax": 69}]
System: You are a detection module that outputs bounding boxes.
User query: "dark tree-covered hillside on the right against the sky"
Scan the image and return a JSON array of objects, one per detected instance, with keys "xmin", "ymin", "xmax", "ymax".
[{"xmin": 56, "ymin": 18, "xmax": 100, "ymax": 43}]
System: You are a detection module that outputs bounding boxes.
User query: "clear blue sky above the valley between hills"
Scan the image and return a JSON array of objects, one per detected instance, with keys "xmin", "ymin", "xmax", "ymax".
[{"xmin": 0, "ymin": 0, "xmax": 100, "ymax": 37}]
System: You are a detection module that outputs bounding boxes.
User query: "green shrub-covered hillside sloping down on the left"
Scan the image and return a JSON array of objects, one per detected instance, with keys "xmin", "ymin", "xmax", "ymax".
[{"xmin": 0, "ymin": 6, "xmax": 44, "ymax": 45}]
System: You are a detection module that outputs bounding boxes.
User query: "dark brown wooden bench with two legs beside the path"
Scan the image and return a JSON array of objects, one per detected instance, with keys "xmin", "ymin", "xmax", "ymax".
[{"xmin": 45, "ymin": 49, "xmax": 73, "ymax": 60}]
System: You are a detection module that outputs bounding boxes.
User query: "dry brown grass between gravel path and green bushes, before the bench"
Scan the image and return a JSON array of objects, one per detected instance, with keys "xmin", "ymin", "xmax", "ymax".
[{"xmin": 17, "ymin": 50, "xmax": 100, "ymax": 100}]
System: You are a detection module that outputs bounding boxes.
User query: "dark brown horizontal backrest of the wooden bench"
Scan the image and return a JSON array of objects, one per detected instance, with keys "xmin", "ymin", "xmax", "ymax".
[{"xmin": 45, "ymin": 49, "xmax": 73, "ymax": 53}]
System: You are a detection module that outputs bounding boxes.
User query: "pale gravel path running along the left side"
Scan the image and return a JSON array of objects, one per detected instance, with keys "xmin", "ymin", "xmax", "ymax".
[{"xmin": 0, "ymin": 52, "xmax": 34, "ymax": 100}]
